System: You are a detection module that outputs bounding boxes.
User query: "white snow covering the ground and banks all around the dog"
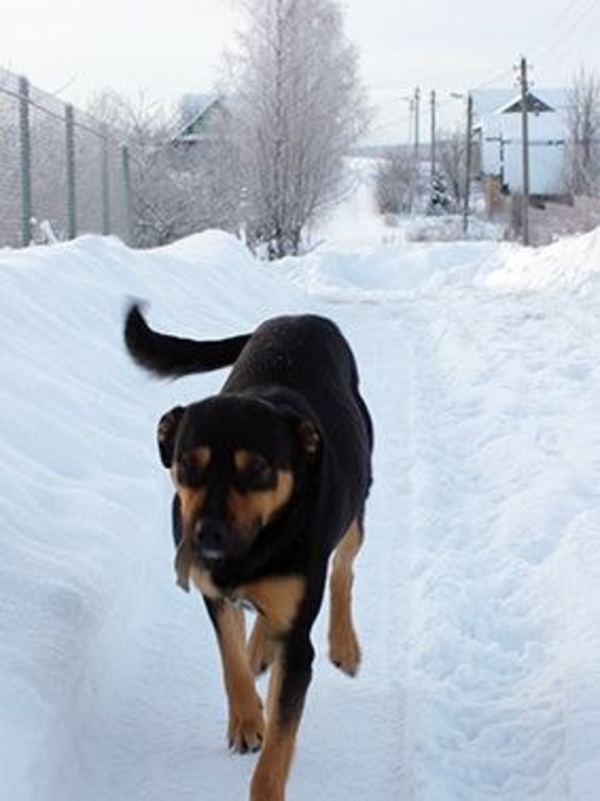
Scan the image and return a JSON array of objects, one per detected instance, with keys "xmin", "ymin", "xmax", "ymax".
[{"xmin": 0, "ymin": 167, "xmax": 600, "ymax": 801}]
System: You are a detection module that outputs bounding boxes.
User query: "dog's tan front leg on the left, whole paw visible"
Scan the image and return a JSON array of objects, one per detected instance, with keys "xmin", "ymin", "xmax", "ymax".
[{"xmin": 204, "ymin": 598, "xmax": 264, "ymax": 753}]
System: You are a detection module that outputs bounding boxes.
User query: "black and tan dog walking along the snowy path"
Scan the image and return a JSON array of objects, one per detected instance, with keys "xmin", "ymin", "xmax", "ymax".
[{"xmin": 125, "ymin": 306, "xmax": 373, "ymax": 801}]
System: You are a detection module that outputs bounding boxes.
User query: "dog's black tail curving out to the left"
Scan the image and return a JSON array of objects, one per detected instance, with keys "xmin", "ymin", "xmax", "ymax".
[{"xmin": 124, "ymin": 303, "xmax": 251, "ymax": 378}]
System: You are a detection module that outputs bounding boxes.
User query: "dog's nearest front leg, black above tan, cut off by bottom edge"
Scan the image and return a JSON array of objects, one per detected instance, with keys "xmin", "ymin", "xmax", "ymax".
[{"xmin": 250, "ymin": 631, "xmax": 314, "ymax": 801}]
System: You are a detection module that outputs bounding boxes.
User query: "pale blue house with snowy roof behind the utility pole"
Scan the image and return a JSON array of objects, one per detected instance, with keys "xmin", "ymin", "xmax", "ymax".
[{"xmin": 474, "ymin": 89, "xmax": 567, "ymax": 203}]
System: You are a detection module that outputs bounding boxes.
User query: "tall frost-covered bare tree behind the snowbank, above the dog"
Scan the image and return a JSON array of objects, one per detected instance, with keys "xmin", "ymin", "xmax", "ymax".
[{"xmin": 223, "ymin": 0, "xmax": 367, "ymax": 258}]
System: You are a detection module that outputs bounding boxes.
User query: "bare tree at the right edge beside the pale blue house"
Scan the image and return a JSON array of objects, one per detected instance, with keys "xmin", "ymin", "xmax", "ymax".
[{"xmin": 567, "ymin": 68, "xmax": 600, "ymax": 195}]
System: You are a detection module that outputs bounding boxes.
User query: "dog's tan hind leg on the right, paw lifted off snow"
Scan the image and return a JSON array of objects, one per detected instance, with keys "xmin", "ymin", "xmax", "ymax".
[{"xmin": 329, "ymin": 519, "xmax": 363, "ymax": 676}]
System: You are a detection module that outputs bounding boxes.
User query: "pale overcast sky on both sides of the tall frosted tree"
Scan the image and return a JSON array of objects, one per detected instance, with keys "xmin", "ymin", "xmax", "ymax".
[{"xmin": 0, "ymin": 0, "xmax": 600, "ymax": 140}]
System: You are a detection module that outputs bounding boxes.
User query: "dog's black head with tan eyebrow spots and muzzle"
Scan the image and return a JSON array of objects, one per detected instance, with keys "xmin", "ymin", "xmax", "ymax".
[{"xmin": 158, "ymin": 395, "xmax": 321, "ymax": 589}]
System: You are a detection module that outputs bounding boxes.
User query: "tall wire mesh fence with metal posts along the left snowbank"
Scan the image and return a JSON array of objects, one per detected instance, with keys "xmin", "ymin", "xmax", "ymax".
[{"xmin": 0, "ymin": 69, "xmax": 133, "ymax": 247}]
